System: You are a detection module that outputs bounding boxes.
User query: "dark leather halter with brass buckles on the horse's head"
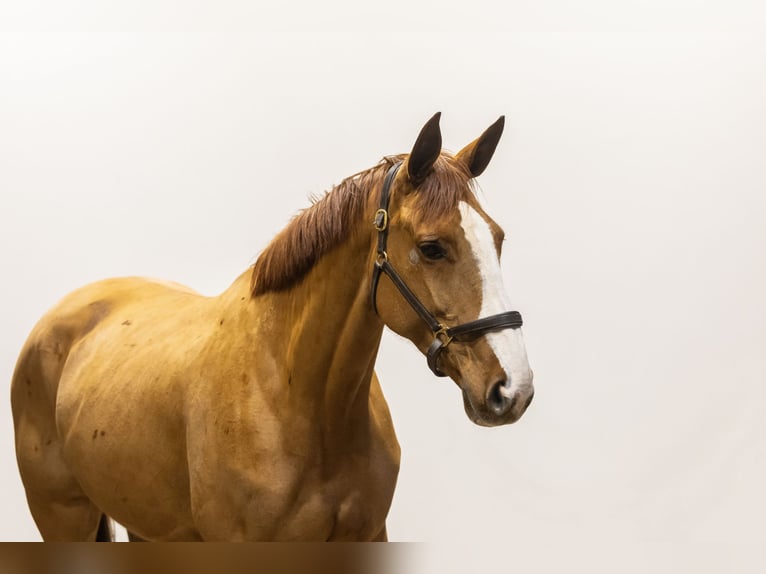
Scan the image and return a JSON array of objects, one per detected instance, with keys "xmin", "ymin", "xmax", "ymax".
[{"xmin": 371, "ymin": 162, "xmax": 522, "ymax": 377}]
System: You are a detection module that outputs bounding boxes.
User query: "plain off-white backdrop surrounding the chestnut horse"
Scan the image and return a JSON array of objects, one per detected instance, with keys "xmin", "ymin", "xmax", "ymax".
[{"xmin": 0, "ymin": 0, "xmax": 766, "ymax": 572}]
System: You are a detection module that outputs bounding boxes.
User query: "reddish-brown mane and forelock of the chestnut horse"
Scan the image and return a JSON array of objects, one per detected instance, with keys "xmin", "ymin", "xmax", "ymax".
[{"xmin": 251, "ymin": 153, "xmax": 472, "ymax": 296}]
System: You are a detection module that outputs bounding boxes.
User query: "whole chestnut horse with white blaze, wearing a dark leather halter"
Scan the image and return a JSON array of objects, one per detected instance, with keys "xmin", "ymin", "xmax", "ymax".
[{"xmin": 11, "ymin": 114, "xmax": 534, "ymax": 541}]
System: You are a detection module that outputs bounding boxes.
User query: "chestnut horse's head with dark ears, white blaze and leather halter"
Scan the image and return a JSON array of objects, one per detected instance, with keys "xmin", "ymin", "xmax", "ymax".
[{"xmin": 373, "ymin": 114, "xmax": 534, "ymax": 426}]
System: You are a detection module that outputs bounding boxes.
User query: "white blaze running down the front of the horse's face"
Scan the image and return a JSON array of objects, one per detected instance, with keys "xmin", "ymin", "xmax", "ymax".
[{"xmin": 460, "ymin": 201, "xmax": 532, "ymax": 396}]
